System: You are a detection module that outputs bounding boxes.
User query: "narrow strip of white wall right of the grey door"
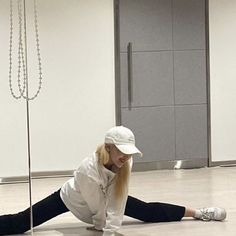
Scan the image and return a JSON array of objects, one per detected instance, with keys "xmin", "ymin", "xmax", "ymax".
[{"xmin": 209, "ymin": 0, "xmax": 236, "ymax": 162}]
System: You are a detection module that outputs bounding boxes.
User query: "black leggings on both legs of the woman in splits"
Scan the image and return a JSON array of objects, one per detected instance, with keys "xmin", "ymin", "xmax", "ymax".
[{"xmin": 0, "ymin": 189, "xmax": 185, "ymax": 235}]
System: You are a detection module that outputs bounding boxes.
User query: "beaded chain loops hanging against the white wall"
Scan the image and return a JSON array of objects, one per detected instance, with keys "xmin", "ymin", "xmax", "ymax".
[{"xmin": 9, "ymin": 0, "xmax": 42, "ymax": 100}]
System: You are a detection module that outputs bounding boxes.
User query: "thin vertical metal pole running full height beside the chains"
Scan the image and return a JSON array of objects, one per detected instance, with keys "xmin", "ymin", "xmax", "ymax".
[{"xmin": 24, "ymin": 0, "xmax": 33, "ymax": 235}]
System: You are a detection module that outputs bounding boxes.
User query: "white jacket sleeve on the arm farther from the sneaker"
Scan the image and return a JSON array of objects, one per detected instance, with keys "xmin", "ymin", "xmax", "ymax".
[{"xmin": 75, "ymin": 172, "xmax": 106, "ymax": 230}]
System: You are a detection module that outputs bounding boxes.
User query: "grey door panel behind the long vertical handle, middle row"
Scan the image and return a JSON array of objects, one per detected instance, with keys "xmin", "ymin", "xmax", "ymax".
[{"xmin": 121, "ymin": 51, "xmax": 174, "ymax": 107}]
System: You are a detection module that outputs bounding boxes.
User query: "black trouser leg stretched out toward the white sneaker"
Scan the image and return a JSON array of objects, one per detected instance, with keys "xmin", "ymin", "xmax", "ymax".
[{"xmin": 125, "ymin": 196, "xmax": 185, "ymax": 222}]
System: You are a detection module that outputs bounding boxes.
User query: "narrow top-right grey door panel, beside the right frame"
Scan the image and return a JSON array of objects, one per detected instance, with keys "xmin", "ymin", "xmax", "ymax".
[{"xmin": 173, "ymin": 0, "xmax": 205, "ymax": 50}]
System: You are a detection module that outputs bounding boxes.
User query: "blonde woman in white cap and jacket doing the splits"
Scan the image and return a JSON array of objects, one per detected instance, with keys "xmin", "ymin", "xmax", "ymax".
[{"xmin": 0, "ymin": 126, "xmax": 226, "ymax": 235}]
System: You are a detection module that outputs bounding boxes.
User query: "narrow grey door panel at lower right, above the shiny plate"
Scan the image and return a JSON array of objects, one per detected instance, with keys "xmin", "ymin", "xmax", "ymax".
[{"xmin": 175, "ymin": 105, "xmax": 208, "ymax": 160}]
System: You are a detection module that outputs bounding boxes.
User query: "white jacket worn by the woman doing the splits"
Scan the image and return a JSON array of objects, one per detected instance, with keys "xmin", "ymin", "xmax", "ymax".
[{"xmin": 60, "ymin": 153, "xmax": 132, "ymax": 234}]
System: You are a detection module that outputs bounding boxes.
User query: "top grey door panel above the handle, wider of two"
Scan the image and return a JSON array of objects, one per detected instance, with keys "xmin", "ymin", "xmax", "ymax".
[{"xmin": 120, "ymin": 0, "xmax": 172, "ymax": 52}]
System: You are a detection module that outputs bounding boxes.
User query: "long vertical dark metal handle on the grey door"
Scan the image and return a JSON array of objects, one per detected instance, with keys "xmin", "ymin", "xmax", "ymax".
[{"xmin": 127, "ymin": 42, "xmax": 133, "ymax": 110}]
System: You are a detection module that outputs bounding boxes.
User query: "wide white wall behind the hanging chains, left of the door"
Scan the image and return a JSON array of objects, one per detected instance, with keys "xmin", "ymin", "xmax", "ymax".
[{"xmin": 0, "ymin": 0, "xmax": 115, "ymax": 177}]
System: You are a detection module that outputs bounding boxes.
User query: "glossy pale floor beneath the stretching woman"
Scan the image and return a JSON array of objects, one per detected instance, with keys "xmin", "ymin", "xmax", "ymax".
[{"xmin": 0, "ymin": 167, "xmax": 236, "ymax": 236}]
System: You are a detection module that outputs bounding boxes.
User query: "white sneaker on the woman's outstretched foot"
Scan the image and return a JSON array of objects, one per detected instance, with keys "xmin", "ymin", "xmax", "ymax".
[{"xmin": 195, "ymin": 207, "xmax": 226, "ymax": 221}]
